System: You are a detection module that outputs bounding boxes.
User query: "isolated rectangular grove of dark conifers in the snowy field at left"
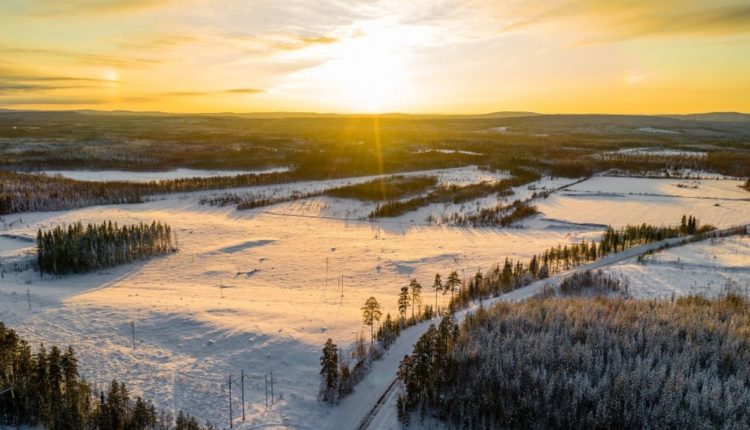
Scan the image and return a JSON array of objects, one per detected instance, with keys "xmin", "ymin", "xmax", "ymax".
[{"xmin": 36, "ymin": 221, "xmax": 177, "ymax": 275}]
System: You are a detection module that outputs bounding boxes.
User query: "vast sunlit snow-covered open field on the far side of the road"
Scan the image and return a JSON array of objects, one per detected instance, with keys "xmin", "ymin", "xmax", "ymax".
[{"xmin": 0, "ymin": 168, "xmax": 750, "ymax": 429}]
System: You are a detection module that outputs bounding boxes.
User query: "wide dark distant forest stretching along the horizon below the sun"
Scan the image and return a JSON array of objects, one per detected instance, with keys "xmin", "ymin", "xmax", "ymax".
[{"xmin": 0, "ymin": 112, "xmax": 750, "ymax": 216}]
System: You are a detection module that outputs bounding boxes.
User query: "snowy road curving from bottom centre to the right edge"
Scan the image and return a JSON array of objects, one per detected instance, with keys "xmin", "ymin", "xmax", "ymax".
[{"xmin": 350, "ymin": 225, "xmax": 750, "ymax": 430}]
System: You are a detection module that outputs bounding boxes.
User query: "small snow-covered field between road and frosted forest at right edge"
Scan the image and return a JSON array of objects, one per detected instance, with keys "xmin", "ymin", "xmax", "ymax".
[{"xmin": 605, "ymin": 236, "xmax": 750, "ymax": 299}]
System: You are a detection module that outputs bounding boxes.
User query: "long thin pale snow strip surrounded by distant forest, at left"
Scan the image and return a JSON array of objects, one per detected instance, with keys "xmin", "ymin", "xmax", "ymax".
[{"xmin": 38, "ymin": 167, "xmax": 289, "ymax": 182}]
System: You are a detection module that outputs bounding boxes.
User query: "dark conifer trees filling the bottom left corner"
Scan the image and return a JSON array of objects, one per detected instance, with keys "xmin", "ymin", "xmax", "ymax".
[{"xmin": 0, "ymin": 322, "xmax": 212, "ymax": 430}]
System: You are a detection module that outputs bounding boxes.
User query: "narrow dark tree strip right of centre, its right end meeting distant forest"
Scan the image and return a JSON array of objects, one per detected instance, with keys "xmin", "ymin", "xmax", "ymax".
[{"xmin": 369, "ymin": 169, "xmax": 541, "ymax": 218}]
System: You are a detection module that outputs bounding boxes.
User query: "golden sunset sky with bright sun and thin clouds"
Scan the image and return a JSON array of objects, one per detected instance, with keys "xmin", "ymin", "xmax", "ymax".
[{"xmin": 0, "ymin": 0, "xmax": 750, "ymax": 114}]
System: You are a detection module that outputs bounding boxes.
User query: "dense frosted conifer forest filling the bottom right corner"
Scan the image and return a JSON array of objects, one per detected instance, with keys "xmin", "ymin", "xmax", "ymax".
[{"xmin": 397, "ymin": 296, "xmax": 750, "ymax": 429}]
